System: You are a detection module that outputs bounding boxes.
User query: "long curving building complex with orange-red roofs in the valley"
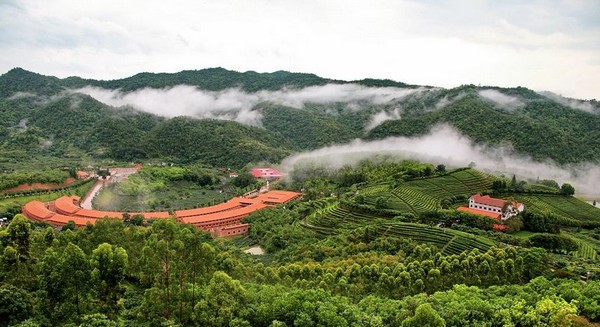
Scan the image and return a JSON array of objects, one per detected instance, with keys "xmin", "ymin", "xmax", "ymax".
[{"xmin": 22, "ymin": 191, "xmax": 302, "ymax": 237}]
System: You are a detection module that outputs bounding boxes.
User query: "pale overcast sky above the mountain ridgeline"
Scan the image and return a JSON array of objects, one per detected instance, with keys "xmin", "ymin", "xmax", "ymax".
[{"xmin": 0, "ymin": 0, "xmax": 600, "ymax": 99}]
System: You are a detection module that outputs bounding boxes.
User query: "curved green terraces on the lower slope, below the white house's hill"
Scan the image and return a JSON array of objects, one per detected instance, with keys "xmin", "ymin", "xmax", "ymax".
[{"xmin": 304, "ymin": 205, "xmax": 494, "ymax": 255}]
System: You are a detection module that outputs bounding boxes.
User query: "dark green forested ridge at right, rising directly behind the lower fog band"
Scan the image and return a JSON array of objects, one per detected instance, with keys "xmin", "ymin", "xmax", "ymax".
[{"xmin": 367, "ymin": 90, "xmax": 600, "ymax": 163}]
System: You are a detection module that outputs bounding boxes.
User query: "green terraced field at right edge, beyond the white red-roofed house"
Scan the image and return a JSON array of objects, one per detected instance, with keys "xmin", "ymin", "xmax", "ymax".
[{"xmin": 514, "ymin": 194, "xmax": 600, "ymax": 222}]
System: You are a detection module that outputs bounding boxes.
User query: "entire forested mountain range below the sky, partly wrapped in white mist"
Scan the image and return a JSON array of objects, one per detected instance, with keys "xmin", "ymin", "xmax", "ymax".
[{"xmin": 0, "ymin": 68, "xmax": 600, "ymax": 166}]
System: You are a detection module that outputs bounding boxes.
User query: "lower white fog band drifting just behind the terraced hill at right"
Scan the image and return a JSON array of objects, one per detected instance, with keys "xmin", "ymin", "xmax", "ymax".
[{"xmin": 281, "ymin": 125, "xmax": 600, "ymax": 198}]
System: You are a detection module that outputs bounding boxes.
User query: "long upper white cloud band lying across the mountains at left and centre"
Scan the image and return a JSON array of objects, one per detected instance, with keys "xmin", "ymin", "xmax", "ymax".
[{"xmin": 74, "ymin": 84, "xmax": 421, "ymax": 126}]
